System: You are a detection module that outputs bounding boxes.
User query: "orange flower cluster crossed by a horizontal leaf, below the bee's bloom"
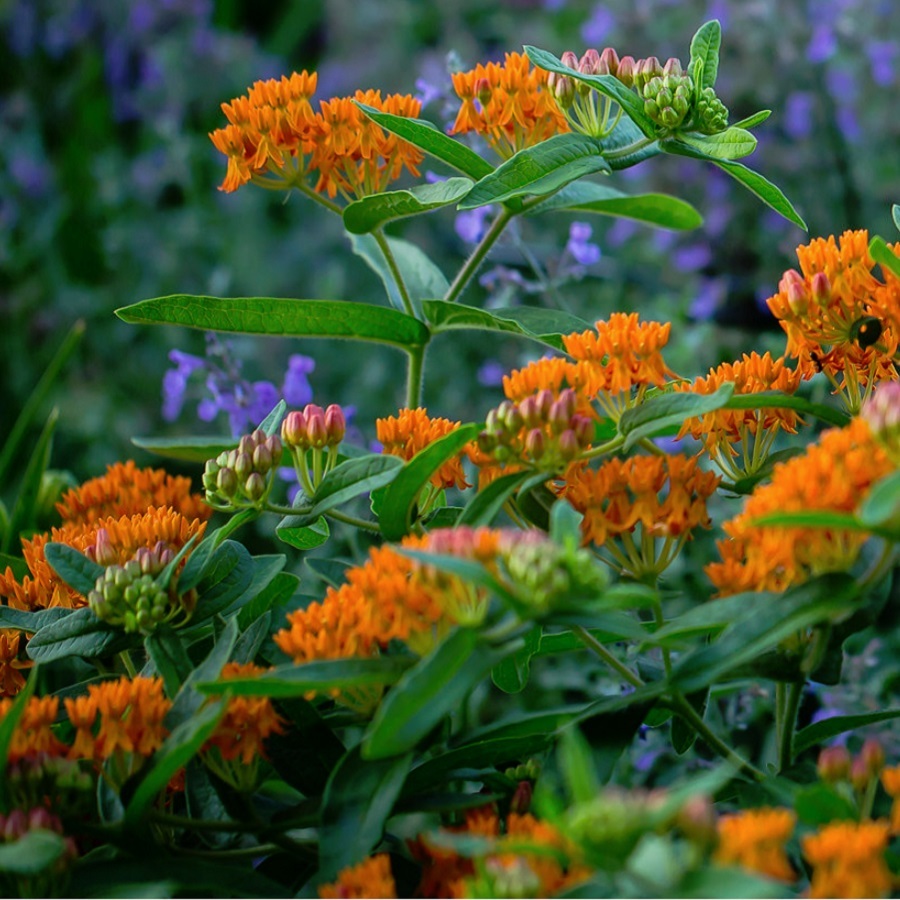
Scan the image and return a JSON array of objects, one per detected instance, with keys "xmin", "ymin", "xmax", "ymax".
[{"xmin": 675, "ymin": 351, "xmax": 802, "ymax": 481}]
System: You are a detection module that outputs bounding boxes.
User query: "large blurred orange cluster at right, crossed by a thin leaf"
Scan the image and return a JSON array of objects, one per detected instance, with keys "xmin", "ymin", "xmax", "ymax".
[{"xmin": 706, "ymin": 418, "xmax": 893, "ymax": 596}]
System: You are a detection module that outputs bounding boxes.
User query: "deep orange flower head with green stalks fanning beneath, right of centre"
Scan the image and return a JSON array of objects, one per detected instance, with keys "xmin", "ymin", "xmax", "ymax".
[{"xmin": 562, "ymin": 454, "xmax": 719, "ymax": 579}]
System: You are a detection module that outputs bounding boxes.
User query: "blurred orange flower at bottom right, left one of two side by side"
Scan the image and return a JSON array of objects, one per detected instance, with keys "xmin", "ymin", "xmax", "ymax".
[{"xmin": 714, "ymin": 807, "xmax": 797, "ymax": 881}]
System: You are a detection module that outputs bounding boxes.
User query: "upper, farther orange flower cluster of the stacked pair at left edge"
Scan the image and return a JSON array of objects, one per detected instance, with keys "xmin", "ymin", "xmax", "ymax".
[{"xmin": 56, "ymin": 460, "xmax": 212, "ymax": 525}]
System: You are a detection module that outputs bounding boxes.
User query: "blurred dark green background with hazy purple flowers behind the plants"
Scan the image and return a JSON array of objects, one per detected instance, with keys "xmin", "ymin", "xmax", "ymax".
[{"xmin": 0, "ymin": 0, "xmax": 900, "ymax": 479}]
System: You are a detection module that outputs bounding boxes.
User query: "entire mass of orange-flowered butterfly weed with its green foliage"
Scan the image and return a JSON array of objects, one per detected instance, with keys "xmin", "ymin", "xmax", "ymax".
[{"xmin": 0, "ymin": 21, "xmax": 900, "ymax": 897}]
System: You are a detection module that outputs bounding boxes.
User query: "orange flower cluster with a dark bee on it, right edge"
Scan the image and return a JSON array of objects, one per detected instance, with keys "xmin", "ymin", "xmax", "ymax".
[{"xmin": 767, "ymin": 231, "xmax": 900, "ymax": 414}]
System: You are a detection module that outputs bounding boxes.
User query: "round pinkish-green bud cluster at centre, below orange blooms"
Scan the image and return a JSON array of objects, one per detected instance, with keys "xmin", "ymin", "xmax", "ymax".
[{"xmin": 478, "ymin": 388, "xmax": 594, "ymax": 472}]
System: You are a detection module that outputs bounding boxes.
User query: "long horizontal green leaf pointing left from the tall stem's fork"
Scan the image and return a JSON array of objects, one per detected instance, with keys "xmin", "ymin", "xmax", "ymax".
[{"xmin": 116, "ymin": 294, "xmax": 429, "ymax": 350}]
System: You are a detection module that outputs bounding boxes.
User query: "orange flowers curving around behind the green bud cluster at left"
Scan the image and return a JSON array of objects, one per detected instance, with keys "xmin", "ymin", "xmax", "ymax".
[{"xmin": 0, "ymin": 507, "xmax": 206, "ymax": 610}]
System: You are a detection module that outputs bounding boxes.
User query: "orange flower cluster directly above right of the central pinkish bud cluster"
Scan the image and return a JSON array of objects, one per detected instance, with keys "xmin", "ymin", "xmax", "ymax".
[{"xmin": 563, "ymin": 313, "xmax": 673, "ymax": 421}]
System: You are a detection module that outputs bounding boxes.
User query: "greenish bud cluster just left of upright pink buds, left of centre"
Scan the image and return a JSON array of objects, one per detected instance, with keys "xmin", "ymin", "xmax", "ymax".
[{"xmin": 203, "ymin": 428, "xmax": 281, "ymax": 509}]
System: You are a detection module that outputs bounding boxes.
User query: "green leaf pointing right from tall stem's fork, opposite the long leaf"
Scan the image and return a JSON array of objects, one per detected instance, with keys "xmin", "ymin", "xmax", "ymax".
[{"xmin": 422, "ymin": 300, "xmax": 590, "ymax": 350}]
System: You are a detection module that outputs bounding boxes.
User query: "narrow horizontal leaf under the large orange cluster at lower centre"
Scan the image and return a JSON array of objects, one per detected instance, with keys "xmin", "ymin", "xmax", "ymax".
[{"xmin": 196, "ymin": 656, "xmax": 415, "ymax": 697}]
